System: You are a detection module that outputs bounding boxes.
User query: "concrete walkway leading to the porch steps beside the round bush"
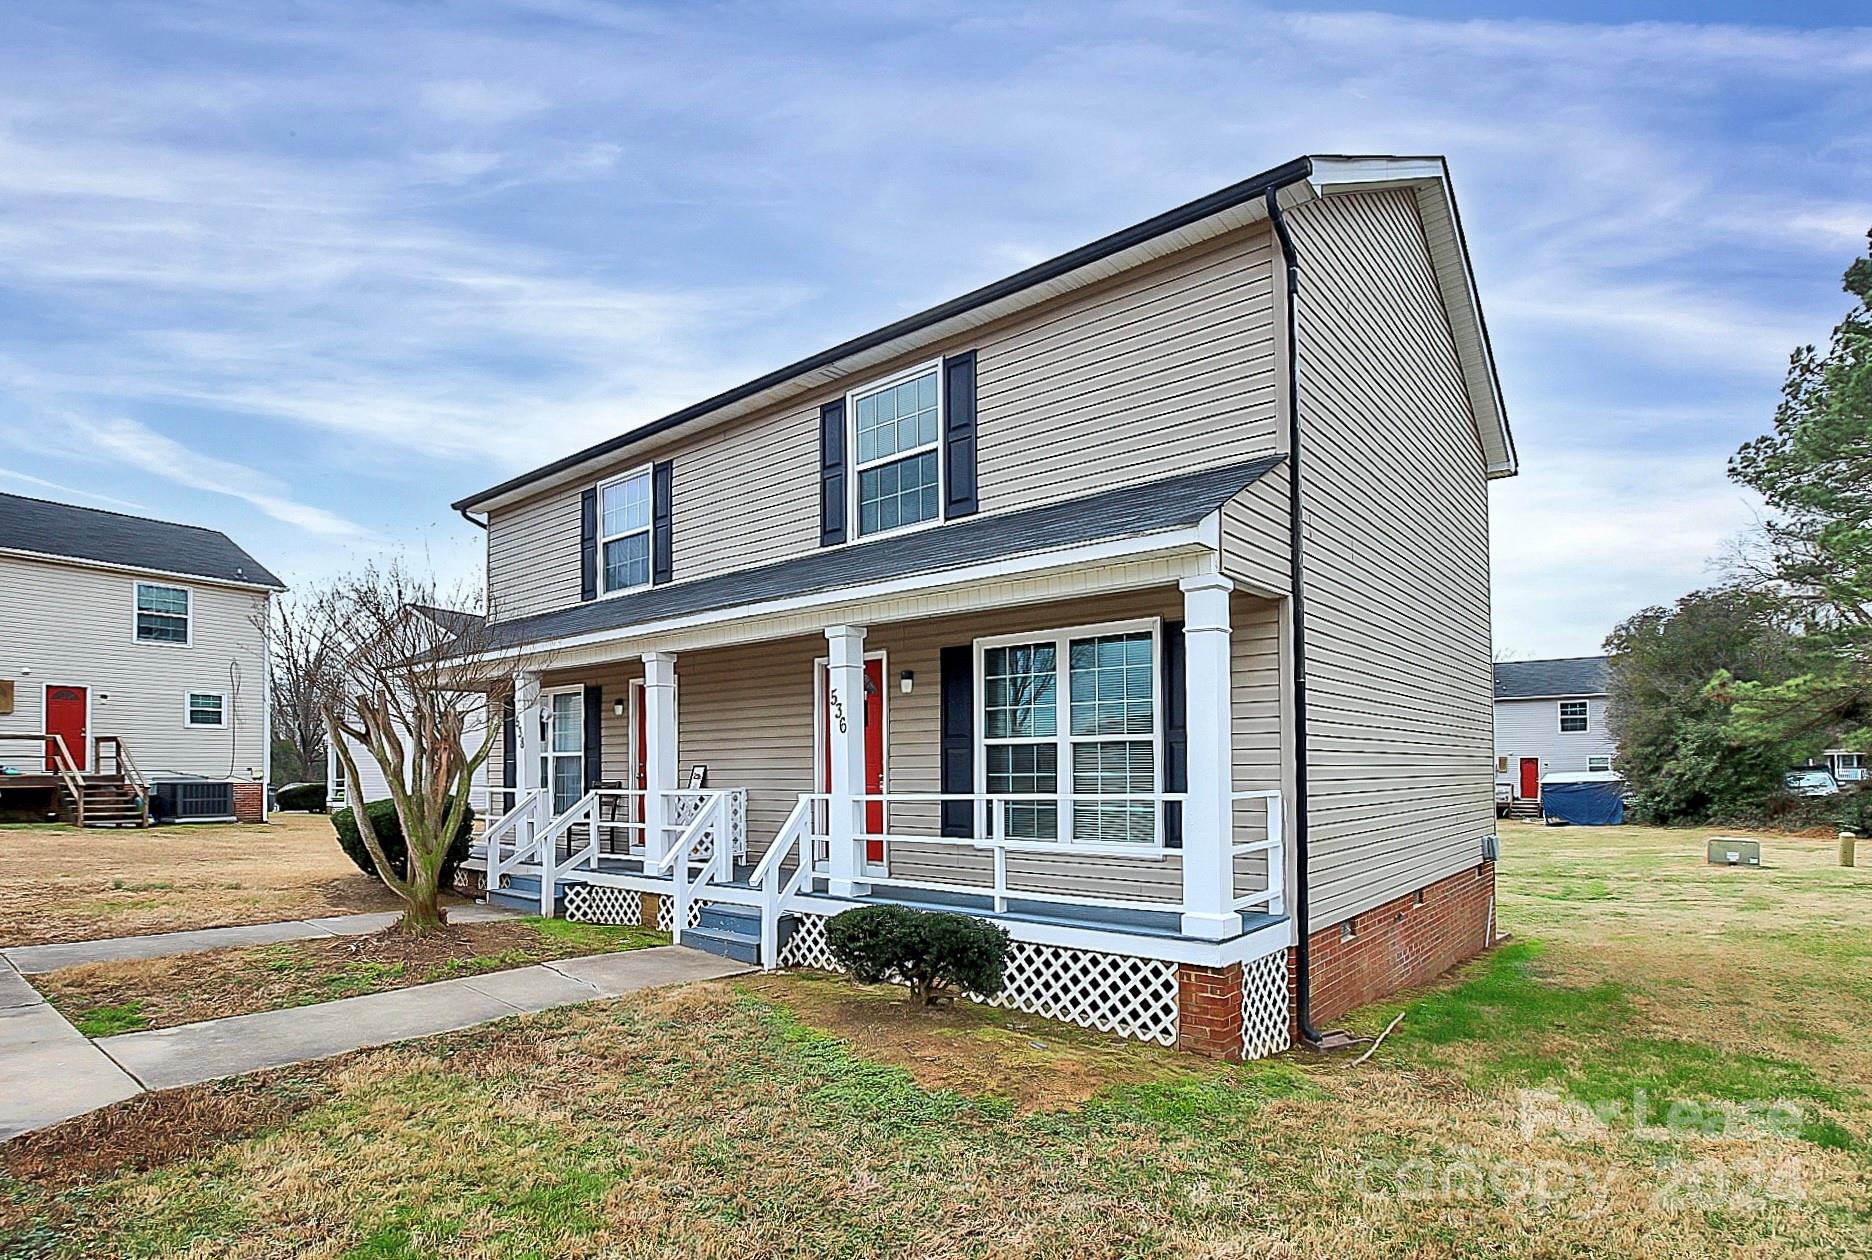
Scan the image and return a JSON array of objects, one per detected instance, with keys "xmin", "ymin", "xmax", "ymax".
[{"xmin": 95, "ymin": 945, "xmax": 751, "ymax": 1090}]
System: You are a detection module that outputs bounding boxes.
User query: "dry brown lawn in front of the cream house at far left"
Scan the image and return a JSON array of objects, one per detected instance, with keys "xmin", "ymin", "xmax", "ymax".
[{"xmin": 0, "ymin": 814, "xmax": 399, "ymax": 945}]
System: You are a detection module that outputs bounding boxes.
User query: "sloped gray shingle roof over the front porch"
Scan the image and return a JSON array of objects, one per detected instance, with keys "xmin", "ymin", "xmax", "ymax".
[{"xmin": 490, "ymin": 455, "xmax": 1286, "ymax": 648}]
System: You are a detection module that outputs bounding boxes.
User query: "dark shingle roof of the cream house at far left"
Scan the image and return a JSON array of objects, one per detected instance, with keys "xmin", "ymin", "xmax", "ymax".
[{"xmin": 0, "ymin": 494, "xmax": 286, "ymax": 590}]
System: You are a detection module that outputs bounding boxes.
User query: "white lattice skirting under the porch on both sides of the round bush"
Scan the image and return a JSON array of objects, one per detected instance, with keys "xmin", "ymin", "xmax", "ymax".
[{"xmin": 781, "ymin": 914, "xmax": 1183, "ymax": 1045}]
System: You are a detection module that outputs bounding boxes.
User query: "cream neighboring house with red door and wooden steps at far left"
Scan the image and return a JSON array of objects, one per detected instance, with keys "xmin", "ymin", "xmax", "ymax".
[{"xmin": 0, "ymin": 494, "xmax": 285, "ymax": 824}]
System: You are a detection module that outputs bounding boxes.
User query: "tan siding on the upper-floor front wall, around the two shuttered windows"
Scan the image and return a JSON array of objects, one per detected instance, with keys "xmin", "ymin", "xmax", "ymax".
[{"xmin": 489, "ymin": 228, "xmax": 1277, "ymax": 620}]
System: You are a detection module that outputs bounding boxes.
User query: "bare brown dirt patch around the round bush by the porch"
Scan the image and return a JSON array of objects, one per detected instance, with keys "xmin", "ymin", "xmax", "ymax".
[{"xmin": 743, "ymin": 972, "xmax": 1206, "ymax": 1112}]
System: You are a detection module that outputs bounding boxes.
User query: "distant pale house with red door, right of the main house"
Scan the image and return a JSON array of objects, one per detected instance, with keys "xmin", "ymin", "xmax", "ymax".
[{"xmin": 1496, "ymin": 657, "xmax": 1617, "ymax": 801}]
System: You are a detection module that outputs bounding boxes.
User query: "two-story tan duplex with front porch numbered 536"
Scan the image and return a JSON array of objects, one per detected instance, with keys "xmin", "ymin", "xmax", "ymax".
[{"xmin": 455, "ymin": 157, "xmax": 1516, "ymax": 1056}]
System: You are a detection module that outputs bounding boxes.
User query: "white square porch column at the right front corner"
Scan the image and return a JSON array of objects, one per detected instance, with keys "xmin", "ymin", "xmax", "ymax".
[{"xmin": 1181, "ymin": 573, "xmax": 1241, "ymax": 940}]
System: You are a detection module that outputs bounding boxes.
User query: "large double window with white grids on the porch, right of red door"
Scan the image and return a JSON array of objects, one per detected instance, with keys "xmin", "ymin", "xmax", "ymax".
[{"xmin": 981, "ymin": 625, "xmax": 1161, "ymax": 844}]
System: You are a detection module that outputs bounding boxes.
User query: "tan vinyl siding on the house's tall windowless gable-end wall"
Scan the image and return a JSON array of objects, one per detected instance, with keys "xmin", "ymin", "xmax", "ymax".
[{"xmin": 1292, "ymin": 191, "xmax": 1494, "ymax": 929}]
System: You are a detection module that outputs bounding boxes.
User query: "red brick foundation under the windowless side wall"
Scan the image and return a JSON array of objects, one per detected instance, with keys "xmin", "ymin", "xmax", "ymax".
[{"xmin": 1288, "ymin": 861, "xmax": 1496, "ymax": 1028}]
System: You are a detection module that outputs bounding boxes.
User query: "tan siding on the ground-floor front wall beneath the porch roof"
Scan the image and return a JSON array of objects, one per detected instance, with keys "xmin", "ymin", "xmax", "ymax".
[{"xmin": 520, "ymin": 588, "xmax": 1282, "ymax": 901}]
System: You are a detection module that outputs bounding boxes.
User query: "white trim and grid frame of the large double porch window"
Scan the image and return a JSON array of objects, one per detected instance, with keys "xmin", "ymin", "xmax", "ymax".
[{"xmin": 970, "ymin": 618, "xmax": 1164, "ymax": 854}]
